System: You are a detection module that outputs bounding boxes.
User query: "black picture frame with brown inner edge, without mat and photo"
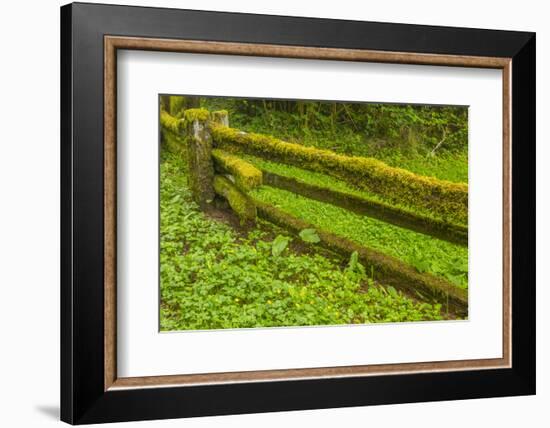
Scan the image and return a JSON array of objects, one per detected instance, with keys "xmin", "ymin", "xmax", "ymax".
[{"xmin": 61, "ymin": 3, "xmax": 536, "ymax": 424}]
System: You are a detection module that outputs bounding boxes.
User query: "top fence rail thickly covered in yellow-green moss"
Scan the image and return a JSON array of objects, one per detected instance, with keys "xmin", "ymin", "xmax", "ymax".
[{"xmin": 211, "ymin": 124, "xmax": 468, "ymax": 225}]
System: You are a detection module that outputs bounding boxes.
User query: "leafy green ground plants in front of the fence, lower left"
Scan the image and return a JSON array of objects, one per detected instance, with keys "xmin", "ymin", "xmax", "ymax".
[{"xmin": 160, "ymin": 152, "xmax": 442, "ymax": 331}]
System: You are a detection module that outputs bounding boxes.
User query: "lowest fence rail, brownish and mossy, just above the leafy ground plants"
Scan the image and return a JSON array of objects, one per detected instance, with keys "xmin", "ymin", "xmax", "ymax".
[{"xmin": 254, "ymin": 200, "xmax": 468, "ymax": 317}]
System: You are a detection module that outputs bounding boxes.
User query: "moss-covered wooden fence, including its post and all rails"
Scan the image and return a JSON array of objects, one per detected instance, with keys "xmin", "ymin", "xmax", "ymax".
[{"xmin": 160, "ymin": 109, "xmax": 468, "ymax": 315}]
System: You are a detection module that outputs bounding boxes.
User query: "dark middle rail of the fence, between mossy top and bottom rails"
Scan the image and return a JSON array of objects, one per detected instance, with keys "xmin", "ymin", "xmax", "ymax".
[{"xmin": 264, "ymin": 170, "xmax": 468, "ymax": 246}]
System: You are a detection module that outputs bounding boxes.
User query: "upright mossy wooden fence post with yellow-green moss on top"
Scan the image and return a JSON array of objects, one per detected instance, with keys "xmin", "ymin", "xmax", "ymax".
[{"xmin": 184, "ymin": 109, "xmax": 214, "ymax": 208}]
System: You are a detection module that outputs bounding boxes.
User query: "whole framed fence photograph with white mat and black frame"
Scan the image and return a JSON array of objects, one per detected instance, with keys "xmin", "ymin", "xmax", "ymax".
[{"xmin": 61, "ymin": 3, "xmax": 535, "ymax": 424}]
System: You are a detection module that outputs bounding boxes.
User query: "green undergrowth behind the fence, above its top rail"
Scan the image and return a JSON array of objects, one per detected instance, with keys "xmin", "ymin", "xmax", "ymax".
[{"xmin": 201, "ymin": 98, "xmax": 468, "ymax": 183}]
